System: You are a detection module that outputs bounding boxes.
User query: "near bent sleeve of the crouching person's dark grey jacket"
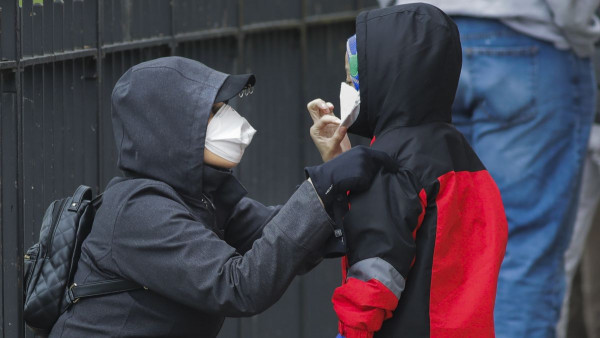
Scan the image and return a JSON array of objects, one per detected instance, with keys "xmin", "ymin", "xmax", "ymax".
[{"xmin": 111, "ymin": 182, "xmax": 332, "ymax": 316}]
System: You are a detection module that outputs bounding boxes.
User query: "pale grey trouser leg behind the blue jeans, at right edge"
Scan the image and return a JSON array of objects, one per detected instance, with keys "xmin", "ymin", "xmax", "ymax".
[{"xmin": 556, "ymin": 125, "xmax": 600, "ymax": 338}]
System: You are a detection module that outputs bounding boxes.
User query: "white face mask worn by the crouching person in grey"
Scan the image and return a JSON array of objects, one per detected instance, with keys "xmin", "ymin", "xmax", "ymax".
[{"xmin": 205, "ymin": 104, "xmax": 256, "ymax": 163}]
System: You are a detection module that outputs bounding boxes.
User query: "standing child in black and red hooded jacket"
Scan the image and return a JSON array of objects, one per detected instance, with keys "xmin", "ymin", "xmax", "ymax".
[{"xmin": 310, "ymin": 4, "xmax": 507, "ymax": 338}]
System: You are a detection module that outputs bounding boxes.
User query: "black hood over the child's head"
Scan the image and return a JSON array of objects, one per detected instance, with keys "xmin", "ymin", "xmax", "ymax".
[{"xmin": 349, "ymin": 3, "xmax": 462, "ymax": 138}]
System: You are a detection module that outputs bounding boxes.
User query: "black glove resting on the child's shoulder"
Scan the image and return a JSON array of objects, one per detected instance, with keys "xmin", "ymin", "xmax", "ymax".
[{"xmin": 304, "ymin": 146, "xmax": 399, "ymax": 217}]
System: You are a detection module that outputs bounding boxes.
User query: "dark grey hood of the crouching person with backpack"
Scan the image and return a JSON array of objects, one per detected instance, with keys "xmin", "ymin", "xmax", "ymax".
[{"xmin": 112, "ymin": 57, "xmax": 227, "ymax": 196}]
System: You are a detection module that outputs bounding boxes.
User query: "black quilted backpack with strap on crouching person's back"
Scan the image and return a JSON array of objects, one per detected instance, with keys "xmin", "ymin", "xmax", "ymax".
[{"xmin": 23, "ymin": 185, "xmax": 141, "ymax": 334}]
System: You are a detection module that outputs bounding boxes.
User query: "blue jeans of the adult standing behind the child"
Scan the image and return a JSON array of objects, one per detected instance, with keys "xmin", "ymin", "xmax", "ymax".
[{"xmin": 452, "ymin": 17, "xmax": 596, "ymax": 338}]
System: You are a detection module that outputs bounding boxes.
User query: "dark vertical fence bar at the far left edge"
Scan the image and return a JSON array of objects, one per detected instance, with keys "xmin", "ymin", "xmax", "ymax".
[{"xmin": 0, "ymin": 4, "xmax": 23, "ymax": 337}]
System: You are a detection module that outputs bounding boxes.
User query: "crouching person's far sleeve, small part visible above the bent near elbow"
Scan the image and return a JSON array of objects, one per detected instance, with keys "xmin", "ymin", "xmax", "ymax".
[{"xmin": 225, "ymin": 197, "xmax": 282, "ymax": 255}]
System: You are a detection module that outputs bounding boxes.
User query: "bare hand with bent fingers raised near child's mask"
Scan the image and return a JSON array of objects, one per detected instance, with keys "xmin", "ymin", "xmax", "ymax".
[{"xmin": 307, "ymin": 99, "xmax": 352, "ymax": 162}]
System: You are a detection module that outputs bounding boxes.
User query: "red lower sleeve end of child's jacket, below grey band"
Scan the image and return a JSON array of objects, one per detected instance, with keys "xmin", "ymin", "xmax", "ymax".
[{"xmin": 332, "ymin": 278, "xmax": 398, "ymax": 338}]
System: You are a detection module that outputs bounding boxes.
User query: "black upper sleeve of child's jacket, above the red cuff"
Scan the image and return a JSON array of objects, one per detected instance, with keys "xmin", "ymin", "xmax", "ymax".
[{"xmin": 344, "ymin": 170, "xmax": 424, "ymax": 297}]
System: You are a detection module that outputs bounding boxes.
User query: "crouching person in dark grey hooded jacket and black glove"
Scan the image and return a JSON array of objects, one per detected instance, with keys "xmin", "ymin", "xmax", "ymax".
[{"xmin": 50, "ymin": 57, "xmax": 394, "ymax": 337}]
